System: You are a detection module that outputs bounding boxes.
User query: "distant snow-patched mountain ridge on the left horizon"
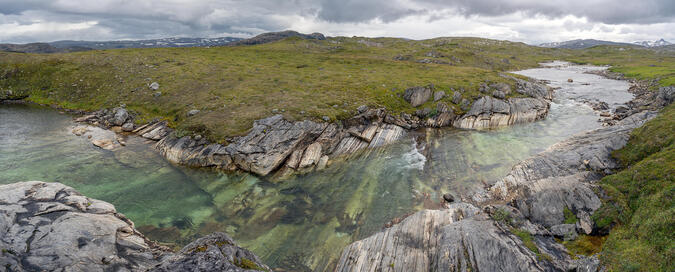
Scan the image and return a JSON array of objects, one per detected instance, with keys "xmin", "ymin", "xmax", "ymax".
[{"xmin": 0, "ymin": 37, "xmax": 241, "ymax": 53}]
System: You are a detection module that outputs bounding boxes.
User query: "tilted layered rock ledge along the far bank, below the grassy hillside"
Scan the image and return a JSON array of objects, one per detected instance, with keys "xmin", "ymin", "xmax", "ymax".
[{"xmin": 70, "ymin": 78, "xmax": 552, "ymax": 176}]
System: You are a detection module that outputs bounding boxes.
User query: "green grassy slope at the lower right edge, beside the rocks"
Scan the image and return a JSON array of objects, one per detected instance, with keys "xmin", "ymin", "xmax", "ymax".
[{"xmin": 593, "ymin": 105, "xmax": 675, "ymax": 271}]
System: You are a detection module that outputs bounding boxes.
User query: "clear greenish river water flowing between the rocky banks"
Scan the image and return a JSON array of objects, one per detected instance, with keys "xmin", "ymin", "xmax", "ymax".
[{"xmin": 0, "ymin": 63, "xmax": 632, "ymax": 271}]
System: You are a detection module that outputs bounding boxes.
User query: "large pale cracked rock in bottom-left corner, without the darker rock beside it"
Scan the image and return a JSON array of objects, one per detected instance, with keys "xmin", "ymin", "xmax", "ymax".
[{"xmin": 0, "ymin": 181, "xmax": 165, "ymax": 271}]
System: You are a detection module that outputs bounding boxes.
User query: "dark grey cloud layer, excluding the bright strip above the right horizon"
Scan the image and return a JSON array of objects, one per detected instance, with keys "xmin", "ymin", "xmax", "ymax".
[{"xmin": 0, "ymin": 0, "xmax": 675, "ymax": 42}]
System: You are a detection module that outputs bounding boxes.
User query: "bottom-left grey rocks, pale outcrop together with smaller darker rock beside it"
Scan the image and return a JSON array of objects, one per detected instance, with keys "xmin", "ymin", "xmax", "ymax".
[{"xmin": 0, "ymin": 181, "xmax": 270, "ymax": 271}]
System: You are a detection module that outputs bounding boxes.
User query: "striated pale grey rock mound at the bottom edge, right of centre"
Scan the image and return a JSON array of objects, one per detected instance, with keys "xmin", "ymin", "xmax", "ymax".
[{"xmin": 335, "ymin": 203, "xmax": 570, "ymax": 271}]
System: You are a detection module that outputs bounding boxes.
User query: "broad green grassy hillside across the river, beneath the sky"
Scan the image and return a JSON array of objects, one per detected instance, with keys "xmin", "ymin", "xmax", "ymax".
[{"xmin": 0, "ymin": 37, "xmax": 675, "ymax": 142}]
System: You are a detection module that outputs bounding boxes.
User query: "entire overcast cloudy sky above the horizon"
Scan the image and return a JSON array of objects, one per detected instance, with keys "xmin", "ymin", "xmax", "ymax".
[{"xmin": 0, "ymin": 0, "xmax": 675, "ymax": 44}]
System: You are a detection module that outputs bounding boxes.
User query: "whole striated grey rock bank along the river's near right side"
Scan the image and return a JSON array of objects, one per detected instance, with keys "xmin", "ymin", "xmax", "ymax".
[{"xmin": 337, "ymin": 82, "xmax": 673, "ymax": 271}]
